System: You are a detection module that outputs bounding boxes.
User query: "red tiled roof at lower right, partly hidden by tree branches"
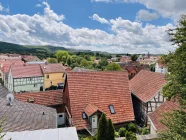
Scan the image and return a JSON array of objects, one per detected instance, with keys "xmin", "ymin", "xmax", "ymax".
[{"xmin": 149, "ymin": 101, "xmax": 179, "ymax": 131}]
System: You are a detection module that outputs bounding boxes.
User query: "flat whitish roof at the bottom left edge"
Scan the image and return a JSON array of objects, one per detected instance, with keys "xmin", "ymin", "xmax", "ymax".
[{"xmin": 3, "ymin": 127, "xmax": 78, "ymax": 140}]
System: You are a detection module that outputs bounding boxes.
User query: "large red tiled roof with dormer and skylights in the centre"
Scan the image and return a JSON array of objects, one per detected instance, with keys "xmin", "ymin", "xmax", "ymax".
[{"xmin": 65, "ymin": 72, "xmax": 134, "ymax": 130}]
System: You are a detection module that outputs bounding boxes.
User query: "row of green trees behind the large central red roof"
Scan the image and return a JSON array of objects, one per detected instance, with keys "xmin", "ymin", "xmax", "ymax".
[{"xmin": 47, "ymin": 51, "xmax": 122, "ymax": 71}]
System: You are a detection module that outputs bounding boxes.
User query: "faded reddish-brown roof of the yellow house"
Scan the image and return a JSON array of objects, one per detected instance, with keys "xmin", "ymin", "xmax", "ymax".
[{"xmin": 41, "ymin": 64, "xmax": 65, "ymax": 74}]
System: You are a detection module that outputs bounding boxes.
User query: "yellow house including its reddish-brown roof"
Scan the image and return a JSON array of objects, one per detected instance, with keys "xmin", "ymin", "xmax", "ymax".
[{"xmin": 41, "ymin": 63, "xmax": 66, "ymax": 90}]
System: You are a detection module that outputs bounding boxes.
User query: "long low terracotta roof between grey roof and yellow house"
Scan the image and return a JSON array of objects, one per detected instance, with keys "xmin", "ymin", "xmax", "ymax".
[{"xmin": 14, "ymin": 90, "xmax": 63, "ymax": 106}]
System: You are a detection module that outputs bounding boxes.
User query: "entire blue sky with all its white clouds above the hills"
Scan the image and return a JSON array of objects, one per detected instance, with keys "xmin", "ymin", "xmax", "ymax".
[{"xmin": 0, "ymin": 0, "xmax": 186, "ymax": 53}]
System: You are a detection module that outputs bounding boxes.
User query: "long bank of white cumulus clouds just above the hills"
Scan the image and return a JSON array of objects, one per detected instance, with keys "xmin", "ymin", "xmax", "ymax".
[{"xmin": 0, "ymin": 2, "xmax": 175, "ymax": 53}]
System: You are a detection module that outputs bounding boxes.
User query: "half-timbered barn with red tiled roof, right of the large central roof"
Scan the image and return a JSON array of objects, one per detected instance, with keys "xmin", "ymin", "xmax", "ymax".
[{"xmin": 129, "ymin": 70, "xmax": 166, "ymax": 126}]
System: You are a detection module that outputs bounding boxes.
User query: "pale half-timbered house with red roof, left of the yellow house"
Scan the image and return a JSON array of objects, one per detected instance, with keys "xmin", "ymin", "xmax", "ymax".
[{"xmin": 8, "ymin": 64, "xmax": 44, "ymax": 93}]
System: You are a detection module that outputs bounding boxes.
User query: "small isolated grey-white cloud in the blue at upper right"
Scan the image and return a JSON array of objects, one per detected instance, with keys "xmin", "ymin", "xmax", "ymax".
[{"xmin": 136, "ymin": 9, "xmax": 159, "ymax": 21}]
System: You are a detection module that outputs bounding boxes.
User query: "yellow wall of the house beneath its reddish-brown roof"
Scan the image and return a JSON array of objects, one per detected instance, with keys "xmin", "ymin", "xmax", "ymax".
[{"xmin": 44, "ymin": 73, "xmax": 65, "ymax": 89}]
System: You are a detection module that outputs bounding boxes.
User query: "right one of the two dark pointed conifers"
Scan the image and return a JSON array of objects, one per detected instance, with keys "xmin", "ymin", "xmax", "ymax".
[{"xmin": 106, "ymin": 119, "xmax": 115, "ymax": 140}]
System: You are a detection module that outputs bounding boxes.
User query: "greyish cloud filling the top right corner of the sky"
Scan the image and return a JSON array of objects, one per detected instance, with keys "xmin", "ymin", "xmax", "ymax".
[{"xmin": 91, "ymin": 0, "xmax": 186, "ymax": 22}]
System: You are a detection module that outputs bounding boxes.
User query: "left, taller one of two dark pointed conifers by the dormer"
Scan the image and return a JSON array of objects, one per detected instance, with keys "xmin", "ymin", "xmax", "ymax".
[{"xmin": 97, "ymin": 113, "xmax": 107, "ymax": 140}]
